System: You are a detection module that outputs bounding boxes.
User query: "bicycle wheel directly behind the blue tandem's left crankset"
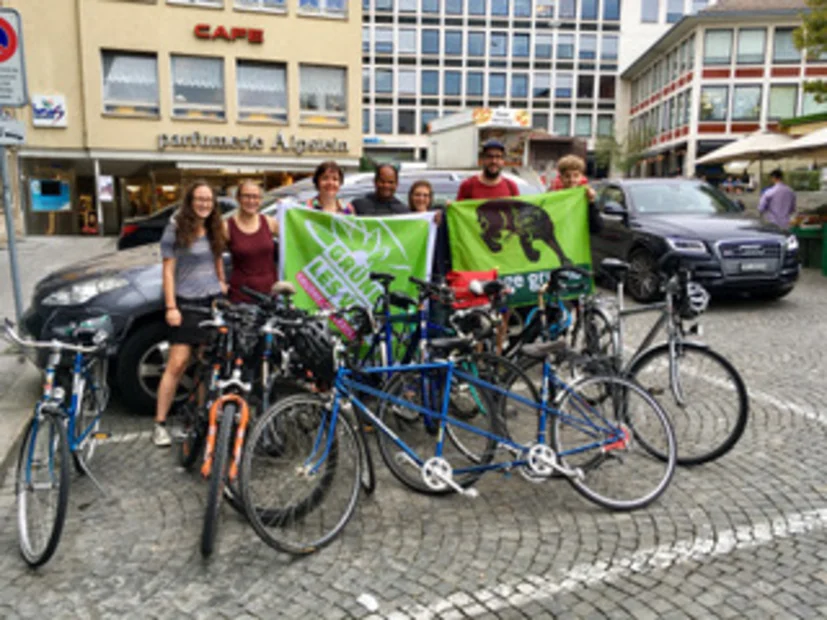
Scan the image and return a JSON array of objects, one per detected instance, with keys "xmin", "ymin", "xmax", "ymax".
[{"xmin": 376, "ymin": 371, "xmax": 503, "ymax": 495}]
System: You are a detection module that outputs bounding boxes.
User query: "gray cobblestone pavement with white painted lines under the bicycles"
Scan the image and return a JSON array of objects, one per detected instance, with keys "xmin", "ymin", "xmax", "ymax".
[{"xmin": 0, "ymin": 271, "xmax": 827, "ymax": 619}]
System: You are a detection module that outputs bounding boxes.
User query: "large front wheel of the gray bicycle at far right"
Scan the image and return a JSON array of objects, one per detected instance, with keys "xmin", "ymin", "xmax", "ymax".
[{"xmin": 628, "ymin": 342, "xmax": 749, "ymax": 465}]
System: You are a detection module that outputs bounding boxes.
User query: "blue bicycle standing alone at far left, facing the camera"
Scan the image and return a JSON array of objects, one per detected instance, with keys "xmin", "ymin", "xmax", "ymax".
[{"xmin": 5, "ymin": 315, "xmax": 113, "ymax": 567}]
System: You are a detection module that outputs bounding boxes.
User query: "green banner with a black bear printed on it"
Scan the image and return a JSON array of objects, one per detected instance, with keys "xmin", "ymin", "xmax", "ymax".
[{"xmin": 448, "ymin": 187, "xmax": 591, "ymax": 305}]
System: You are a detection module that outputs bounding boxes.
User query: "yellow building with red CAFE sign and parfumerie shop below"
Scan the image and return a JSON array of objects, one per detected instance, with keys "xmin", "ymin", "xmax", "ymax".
[{"xmin": 4, "ymin": 0, "xmax": 362, "ymax": 234}]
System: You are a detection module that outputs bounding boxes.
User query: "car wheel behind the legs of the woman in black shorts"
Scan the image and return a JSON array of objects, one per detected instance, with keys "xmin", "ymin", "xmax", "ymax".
[{"xmin": 117, "ymin": 322, "xmax": 192, "ymax": 415}]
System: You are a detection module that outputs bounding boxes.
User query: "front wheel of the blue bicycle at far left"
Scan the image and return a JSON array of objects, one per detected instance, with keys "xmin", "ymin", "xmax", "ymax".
[{"xmin": 15, "ymin": 414, "xmax": 71, "ymax": 567}]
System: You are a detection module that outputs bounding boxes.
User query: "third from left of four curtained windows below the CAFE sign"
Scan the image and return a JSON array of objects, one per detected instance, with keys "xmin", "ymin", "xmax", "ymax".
[{"xmin": 236, "ymin": 60, "xmax": 287, "ymax": 123}]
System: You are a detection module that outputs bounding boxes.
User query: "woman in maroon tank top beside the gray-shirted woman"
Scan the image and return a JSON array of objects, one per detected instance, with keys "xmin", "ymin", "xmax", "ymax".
[{"xmin": 224, "ymin": 181, "xmax": 279, "ymax": 302}]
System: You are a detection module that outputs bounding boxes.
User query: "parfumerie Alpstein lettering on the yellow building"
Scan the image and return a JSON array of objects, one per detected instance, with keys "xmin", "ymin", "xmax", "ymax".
[{"xmin": 158, "ymin": 131, "xmax": 348, "ymax": 155}]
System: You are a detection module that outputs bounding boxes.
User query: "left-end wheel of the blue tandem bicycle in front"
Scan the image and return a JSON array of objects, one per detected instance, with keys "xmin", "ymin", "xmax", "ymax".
[{"xmin": 240, "ymin": 394, "xmax": 362, "ymax": 555}]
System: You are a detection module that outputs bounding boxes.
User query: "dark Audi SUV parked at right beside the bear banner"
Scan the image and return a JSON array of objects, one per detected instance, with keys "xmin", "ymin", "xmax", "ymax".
[{"xmin": 591, "ymin": 179, "xmax": 799, "ymax": 302}]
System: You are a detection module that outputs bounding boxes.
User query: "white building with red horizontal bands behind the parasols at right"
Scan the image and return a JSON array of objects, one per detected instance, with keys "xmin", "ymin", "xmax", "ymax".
[{"xmin": 619, "ymin": 0, "xmax": 827, "ymax": 176}]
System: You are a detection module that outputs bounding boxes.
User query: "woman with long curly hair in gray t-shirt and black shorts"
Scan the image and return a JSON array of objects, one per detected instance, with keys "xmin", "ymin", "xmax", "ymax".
[{"xmin": 152, "ymin": 181, "xmax": 227, "ymax": 446}]
